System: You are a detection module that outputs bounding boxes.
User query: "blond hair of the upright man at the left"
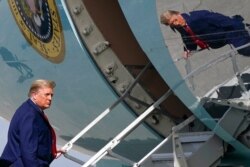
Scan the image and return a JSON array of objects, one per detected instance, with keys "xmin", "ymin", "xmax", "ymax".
[{"xmin": 28, "ymin": 79, "xmax": 56, "ymax": 97}]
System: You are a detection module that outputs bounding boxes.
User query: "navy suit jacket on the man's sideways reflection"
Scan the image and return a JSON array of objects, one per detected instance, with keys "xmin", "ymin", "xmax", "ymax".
[{"xmin": 184, "ymin": 10, "xmax": 244, "ymax": 49}]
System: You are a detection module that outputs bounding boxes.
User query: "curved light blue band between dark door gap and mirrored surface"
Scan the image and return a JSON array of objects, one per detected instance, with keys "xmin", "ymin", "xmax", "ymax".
[{"xmin": 119, "ymin": 0, "xmax": 250, "ymax": 155}]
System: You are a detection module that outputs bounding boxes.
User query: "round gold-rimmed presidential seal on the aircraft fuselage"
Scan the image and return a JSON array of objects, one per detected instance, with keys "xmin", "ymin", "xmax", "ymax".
[{"xmin": 8, "ymin": 0, "xmax": 65, "ymax": 63}]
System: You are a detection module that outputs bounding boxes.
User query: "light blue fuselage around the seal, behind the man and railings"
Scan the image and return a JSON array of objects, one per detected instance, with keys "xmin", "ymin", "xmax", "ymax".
[{"xmin": 0, "ymin": 0, "xmax": 161, "ymax": 162}]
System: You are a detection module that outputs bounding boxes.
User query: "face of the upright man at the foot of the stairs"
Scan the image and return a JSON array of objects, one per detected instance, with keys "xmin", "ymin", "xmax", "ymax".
[{"xmin": 33, "ymin": 87, "xmax": 54, "ymax": 110}]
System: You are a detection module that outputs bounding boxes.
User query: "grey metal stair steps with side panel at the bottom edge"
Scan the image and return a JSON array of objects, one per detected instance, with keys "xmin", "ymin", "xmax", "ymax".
[{"xmin": 141, "ymin": 132, "xmax": 224, "ymax": 167}]
